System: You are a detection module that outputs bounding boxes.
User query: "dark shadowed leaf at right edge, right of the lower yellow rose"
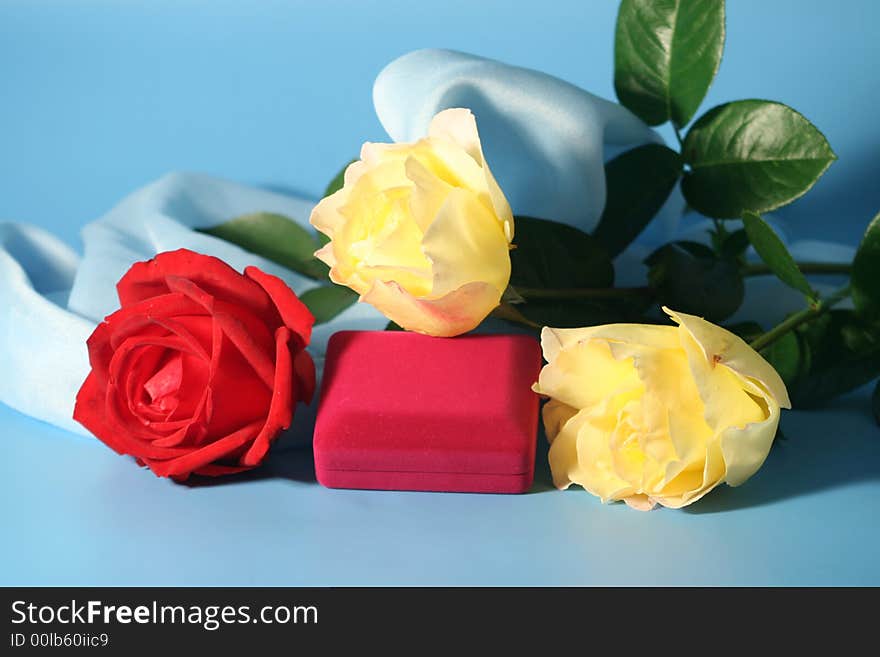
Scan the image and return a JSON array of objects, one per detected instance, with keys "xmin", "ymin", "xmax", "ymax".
[{"xmin": 789, "ymin": 310, "xmax": 880, "ymax": 408}]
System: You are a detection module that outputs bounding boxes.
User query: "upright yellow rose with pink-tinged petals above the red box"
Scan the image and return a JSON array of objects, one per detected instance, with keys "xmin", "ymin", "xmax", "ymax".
[{"xmin": 310, "ymin": 109, "xmax": 513, "ymax": 336}]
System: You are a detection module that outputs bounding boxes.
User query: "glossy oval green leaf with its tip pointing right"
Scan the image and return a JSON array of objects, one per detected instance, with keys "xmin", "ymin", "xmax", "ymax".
[{"xmin": 681, "ymin": 100, "xmax": 837, "ymax": 219}]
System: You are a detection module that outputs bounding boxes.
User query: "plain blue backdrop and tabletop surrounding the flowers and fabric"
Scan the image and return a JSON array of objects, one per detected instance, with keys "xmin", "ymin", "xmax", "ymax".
[{"xmin": 0, "ymin": 0, "xmax": 880, "ymax": 584}]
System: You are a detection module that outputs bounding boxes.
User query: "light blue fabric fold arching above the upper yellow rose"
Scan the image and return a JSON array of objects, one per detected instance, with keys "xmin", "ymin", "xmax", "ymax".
[{"xmin": 373, "ymin": 49, "xmax": 682, "ymax": 232}]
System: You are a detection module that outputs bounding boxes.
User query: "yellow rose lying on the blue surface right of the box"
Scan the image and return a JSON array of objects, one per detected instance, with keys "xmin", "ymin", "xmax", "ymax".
[{"xmin": 534, "ymin": 308, "xmax": 791, "ymax": 510}]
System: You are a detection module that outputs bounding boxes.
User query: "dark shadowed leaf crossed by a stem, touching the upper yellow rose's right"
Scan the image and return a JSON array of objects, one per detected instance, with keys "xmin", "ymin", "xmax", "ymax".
[{"xmin": 510, "ymin": 217, "xmax": 619, "ymax": 327}]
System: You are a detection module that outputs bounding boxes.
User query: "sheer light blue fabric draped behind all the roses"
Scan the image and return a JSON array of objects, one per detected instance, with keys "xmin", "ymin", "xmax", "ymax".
[{"xmin": 0, "ymin": 50, "xmax": 852, "ymax": 438}]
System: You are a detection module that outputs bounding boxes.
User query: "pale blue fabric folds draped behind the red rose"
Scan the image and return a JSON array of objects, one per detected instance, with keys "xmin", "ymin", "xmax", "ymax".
[{"xmin": 0, "ymin": 173, "xmax": 387, "ymax": 440}]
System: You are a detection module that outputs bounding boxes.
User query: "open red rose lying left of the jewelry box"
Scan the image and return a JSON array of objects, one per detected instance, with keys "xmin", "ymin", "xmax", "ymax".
[{"xmin": 73, "ymin": 249, "xmax": 315, "ymax": 479}]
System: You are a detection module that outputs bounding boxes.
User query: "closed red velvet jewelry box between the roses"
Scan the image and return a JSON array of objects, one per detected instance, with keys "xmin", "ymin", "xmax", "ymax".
[{"xmin": 314, "ymin": 331, "xmax": 541, "ymax": 493}]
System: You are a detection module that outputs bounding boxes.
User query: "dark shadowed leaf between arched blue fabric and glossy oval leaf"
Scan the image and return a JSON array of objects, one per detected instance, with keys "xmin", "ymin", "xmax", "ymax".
[{"xmin": 593, "ymin": 144, "xmax": 682, "ymax": 258}]
